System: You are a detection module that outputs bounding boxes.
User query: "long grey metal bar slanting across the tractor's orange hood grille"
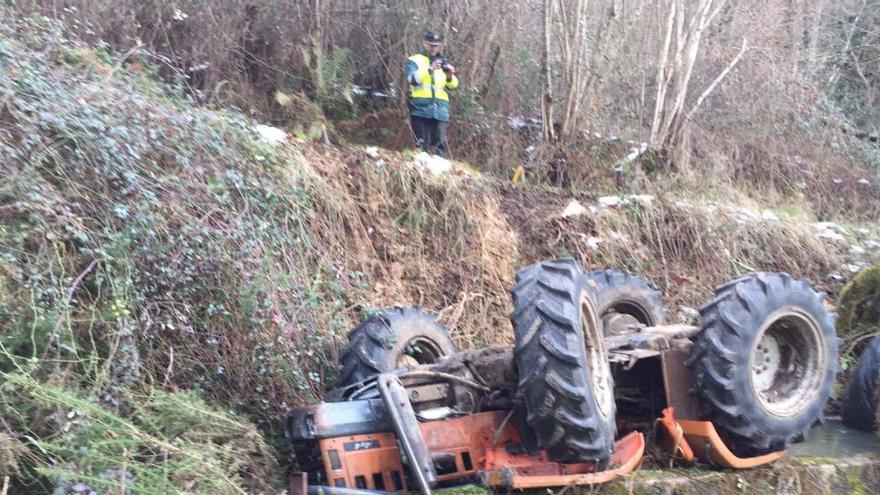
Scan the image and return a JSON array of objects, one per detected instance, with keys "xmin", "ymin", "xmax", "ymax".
[{"xmin": 378, "ymin": 373, "xmax": 437, "ymax": 495}]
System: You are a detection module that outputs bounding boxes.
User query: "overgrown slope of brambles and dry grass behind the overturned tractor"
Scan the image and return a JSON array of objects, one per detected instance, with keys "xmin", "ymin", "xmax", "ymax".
[{"xmin": 0, "ymin": 13, "xmax": 876, "ymax": 493}]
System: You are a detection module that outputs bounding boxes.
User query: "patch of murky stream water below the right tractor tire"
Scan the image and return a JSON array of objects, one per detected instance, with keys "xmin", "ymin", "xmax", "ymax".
[{"xmin": 788, "ymin": 418, "xmax": 880, "ymax": 457}]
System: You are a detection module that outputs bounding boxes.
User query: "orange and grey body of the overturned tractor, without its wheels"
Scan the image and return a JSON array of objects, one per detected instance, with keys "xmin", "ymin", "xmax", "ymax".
[{"xmin": 287, "ymin": 324, "xmax": 784, "ymax": 495}]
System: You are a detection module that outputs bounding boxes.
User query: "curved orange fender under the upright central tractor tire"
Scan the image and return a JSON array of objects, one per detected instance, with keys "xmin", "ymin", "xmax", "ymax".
[{"xmin": 484, "ymin": 432, "xmax": 645, "ymax": 490}]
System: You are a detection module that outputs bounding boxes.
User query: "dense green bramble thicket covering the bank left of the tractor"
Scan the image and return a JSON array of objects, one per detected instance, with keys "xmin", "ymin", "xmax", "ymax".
[{"xmin": 0, "ymin": 11, "xmax": 363, "ymax": 493}]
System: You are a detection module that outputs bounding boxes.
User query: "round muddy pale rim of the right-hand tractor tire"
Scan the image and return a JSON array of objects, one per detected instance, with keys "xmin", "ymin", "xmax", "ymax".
[{"xmin": 749, "ymin": 308, "xmax": 828, "ymax": 418}]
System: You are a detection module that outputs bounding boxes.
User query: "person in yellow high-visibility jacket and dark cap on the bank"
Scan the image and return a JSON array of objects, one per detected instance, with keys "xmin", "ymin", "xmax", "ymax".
[{"xmin": 406, "ymin": 31, "xmax": 458, "ymax": 157}]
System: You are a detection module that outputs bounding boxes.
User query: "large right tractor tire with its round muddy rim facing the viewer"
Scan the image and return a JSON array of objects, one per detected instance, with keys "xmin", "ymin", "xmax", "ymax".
[{"xmin": 689, "ymin": 273, "xmax": 839, "ymax": 456}]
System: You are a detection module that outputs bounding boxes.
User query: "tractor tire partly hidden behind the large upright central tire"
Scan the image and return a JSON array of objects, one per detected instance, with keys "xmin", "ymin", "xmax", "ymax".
[{"xmin": 587, "ymin": 270, "xmax": 666, "ymax": 335}]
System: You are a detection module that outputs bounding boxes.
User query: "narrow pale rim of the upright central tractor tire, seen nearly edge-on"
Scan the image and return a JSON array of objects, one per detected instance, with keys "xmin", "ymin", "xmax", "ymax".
[{"xmin": 581, "ymin": 294, "xmax": 614, "ymax": 418}]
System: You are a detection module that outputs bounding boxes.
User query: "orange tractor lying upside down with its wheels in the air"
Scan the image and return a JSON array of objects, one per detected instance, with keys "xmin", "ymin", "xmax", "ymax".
[{"xmin": 287, "ymin": 259, "xmax": 838, "ymax": 494}]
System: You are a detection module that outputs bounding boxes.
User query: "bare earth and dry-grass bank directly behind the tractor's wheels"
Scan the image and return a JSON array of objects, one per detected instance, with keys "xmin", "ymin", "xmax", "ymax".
[{"xmin": 301, "ymin": 145, "xmax": 880, "ymax": 352}]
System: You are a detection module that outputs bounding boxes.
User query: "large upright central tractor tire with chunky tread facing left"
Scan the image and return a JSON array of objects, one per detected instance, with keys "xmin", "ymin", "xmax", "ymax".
[{"xmin": 510, "ymin": 259, "xmax": 615, "ymax": 467}]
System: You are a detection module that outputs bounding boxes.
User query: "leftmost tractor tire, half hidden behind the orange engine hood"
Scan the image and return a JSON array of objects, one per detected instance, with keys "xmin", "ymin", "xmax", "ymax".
[{"xmin": 337, "ymin": 307, "xmax": 458, "ymax": 388}]
